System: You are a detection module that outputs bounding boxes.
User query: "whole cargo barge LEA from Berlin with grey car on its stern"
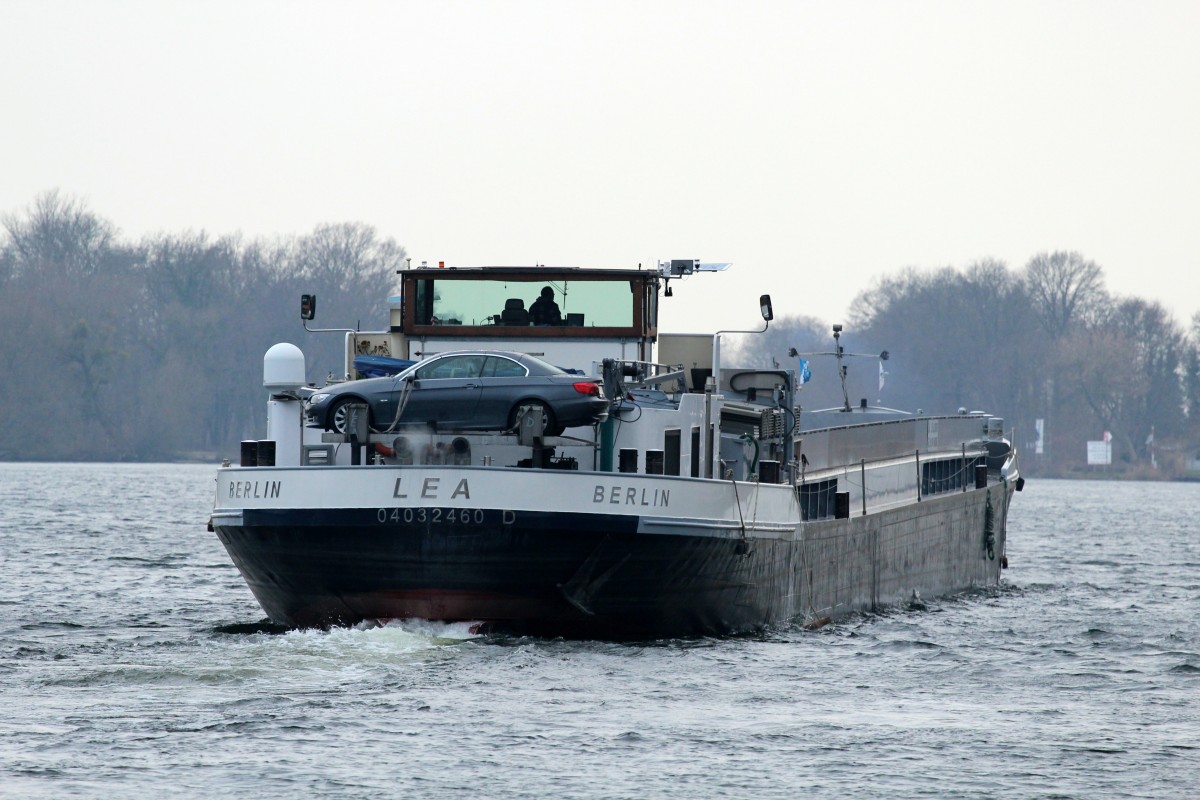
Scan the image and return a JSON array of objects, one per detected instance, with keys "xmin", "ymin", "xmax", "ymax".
[{"xmin": 209, "ymin": 259, "xmax": 1024, "ymax": 639}]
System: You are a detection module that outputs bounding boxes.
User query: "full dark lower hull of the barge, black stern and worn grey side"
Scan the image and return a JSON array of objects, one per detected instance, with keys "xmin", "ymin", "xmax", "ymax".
[{"xmin": 214, "ymin": 474, "xmax": 1010, "ymax": 639}]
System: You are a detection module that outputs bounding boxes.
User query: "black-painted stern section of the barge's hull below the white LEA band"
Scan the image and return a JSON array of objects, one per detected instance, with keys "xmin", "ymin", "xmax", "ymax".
[{"xmin": 215, "ymin": 510, "xmax": 788, "ymax": 638}]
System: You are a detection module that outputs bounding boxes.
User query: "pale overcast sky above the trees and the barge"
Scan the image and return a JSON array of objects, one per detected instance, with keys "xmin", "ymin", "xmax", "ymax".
[{"xmin": 0, "ymin": 0, "xmax": 1200, "ymax": 330}]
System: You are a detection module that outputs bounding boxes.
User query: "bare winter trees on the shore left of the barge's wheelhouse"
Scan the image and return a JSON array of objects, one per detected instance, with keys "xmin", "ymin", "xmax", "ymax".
[{"xmin": 0, "ymin": 192, "xmax": 404, "ymax": 461}]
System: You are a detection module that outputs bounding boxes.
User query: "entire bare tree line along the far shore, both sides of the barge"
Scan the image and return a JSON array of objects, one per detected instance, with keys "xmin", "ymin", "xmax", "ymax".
[{"xmin": 0, "ymin": 192, "xmax": 1200, "ymax": 477}]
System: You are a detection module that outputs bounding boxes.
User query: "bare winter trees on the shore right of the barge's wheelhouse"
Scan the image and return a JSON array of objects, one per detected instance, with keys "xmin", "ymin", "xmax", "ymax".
[{"xmin": 740, "ymin": 251, "xmax": 1200, "ymax": 479}]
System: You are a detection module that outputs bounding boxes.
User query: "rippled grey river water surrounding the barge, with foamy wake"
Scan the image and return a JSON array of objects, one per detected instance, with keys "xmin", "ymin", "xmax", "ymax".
[{"xmin": 0, "ymin": 464, "xmax": 1200, "ymax": 798}]
